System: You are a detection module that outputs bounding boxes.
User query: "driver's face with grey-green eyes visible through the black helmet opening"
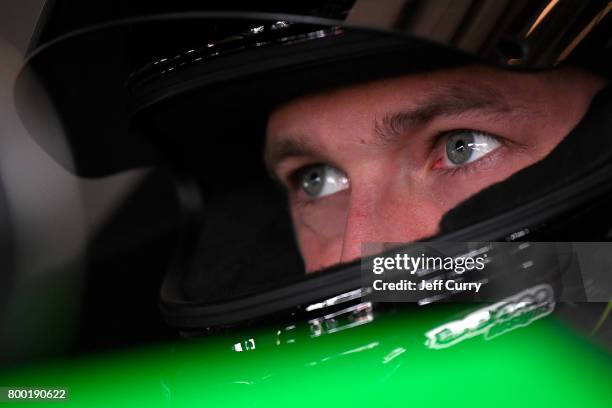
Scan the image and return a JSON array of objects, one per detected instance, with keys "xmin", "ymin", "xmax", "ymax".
[{"xmin": 265, "ymin": 66, "xmax": 603, "ymax": 272}]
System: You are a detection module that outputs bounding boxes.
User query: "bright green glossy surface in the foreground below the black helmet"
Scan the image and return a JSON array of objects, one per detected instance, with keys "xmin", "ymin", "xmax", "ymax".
[{"xmin": 0, "ymin": 305, "xmax": 612, "ymax": 408}]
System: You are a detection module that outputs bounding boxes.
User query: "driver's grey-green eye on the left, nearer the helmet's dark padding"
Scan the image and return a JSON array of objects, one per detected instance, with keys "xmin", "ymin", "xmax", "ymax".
[{"xmin": 292, "ymin": 164, "xmax": 350, "ymax": 199}]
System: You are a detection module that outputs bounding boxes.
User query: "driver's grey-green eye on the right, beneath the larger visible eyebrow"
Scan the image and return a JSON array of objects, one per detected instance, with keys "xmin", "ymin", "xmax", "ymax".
[{"xmin": 439, "ymin": 129, "xmax": 502, "ymax": 168}]
